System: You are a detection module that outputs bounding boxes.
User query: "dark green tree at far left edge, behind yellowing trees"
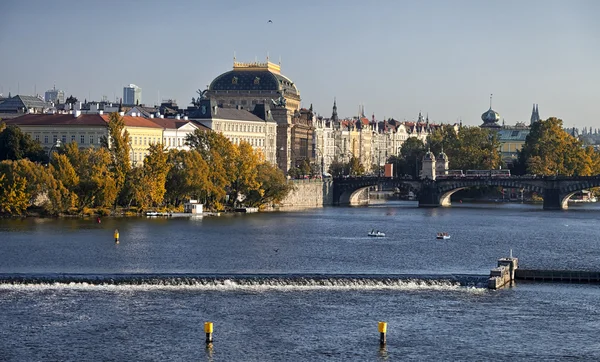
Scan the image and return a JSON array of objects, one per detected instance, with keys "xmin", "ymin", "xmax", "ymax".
[{"xmin": 0, "ymin": 125, "xmax": 48, "ymax": 162}]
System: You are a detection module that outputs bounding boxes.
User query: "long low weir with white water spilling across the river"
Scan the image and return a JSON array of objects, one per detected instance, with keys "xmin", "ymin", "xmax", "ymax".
[{"xmin": 0, "ymin": 274, "xmax": 486, "ymax": 290}]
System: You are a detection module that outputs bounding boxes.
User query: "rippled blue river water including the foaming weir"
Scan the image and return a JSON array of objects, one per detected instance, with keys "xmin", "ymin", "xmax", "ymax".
[{"xmin": 0, "ymin": 202, "xmax": 600, "ymax": 361}]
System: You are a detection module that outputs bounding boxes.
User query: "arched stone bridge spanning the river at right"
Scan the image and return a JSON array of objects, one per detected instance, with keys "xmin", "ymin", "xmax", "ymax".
[{"xmin": 333, "ymin": 176, "xmax": 600, "ymax": 210}]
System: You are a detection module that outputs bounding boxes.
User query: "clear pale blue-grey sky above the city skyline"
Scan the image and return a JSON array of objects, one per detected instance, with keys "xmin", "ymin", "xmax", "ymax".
[{"xmin": 0, "ymin": 0, "xmax": 600, "ymax": 128}]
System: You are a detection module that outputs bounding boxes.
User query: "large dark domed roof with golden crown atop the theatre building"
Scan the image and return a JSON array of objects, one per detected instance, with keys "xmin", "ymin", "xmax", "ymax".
[{"xmin": 206, "ymin": 58, "xmax": 300, "ymax": 112}]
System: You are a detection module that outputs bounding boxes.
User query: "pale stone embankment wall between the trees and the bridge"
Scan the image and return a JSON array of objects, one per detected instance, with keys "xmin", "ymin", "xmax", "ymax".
[{"xmin": 279, "ymin": 180, "xmax": 333, "ymax": 209}]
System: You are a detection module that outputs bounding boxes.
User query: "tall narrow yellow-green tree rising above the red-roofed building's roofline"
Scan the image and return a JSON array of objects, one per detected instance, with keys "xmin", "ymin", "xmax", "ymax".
[{"xmin": 102, "ymin": 112, "xmax": 131, "ymax": 201}]
